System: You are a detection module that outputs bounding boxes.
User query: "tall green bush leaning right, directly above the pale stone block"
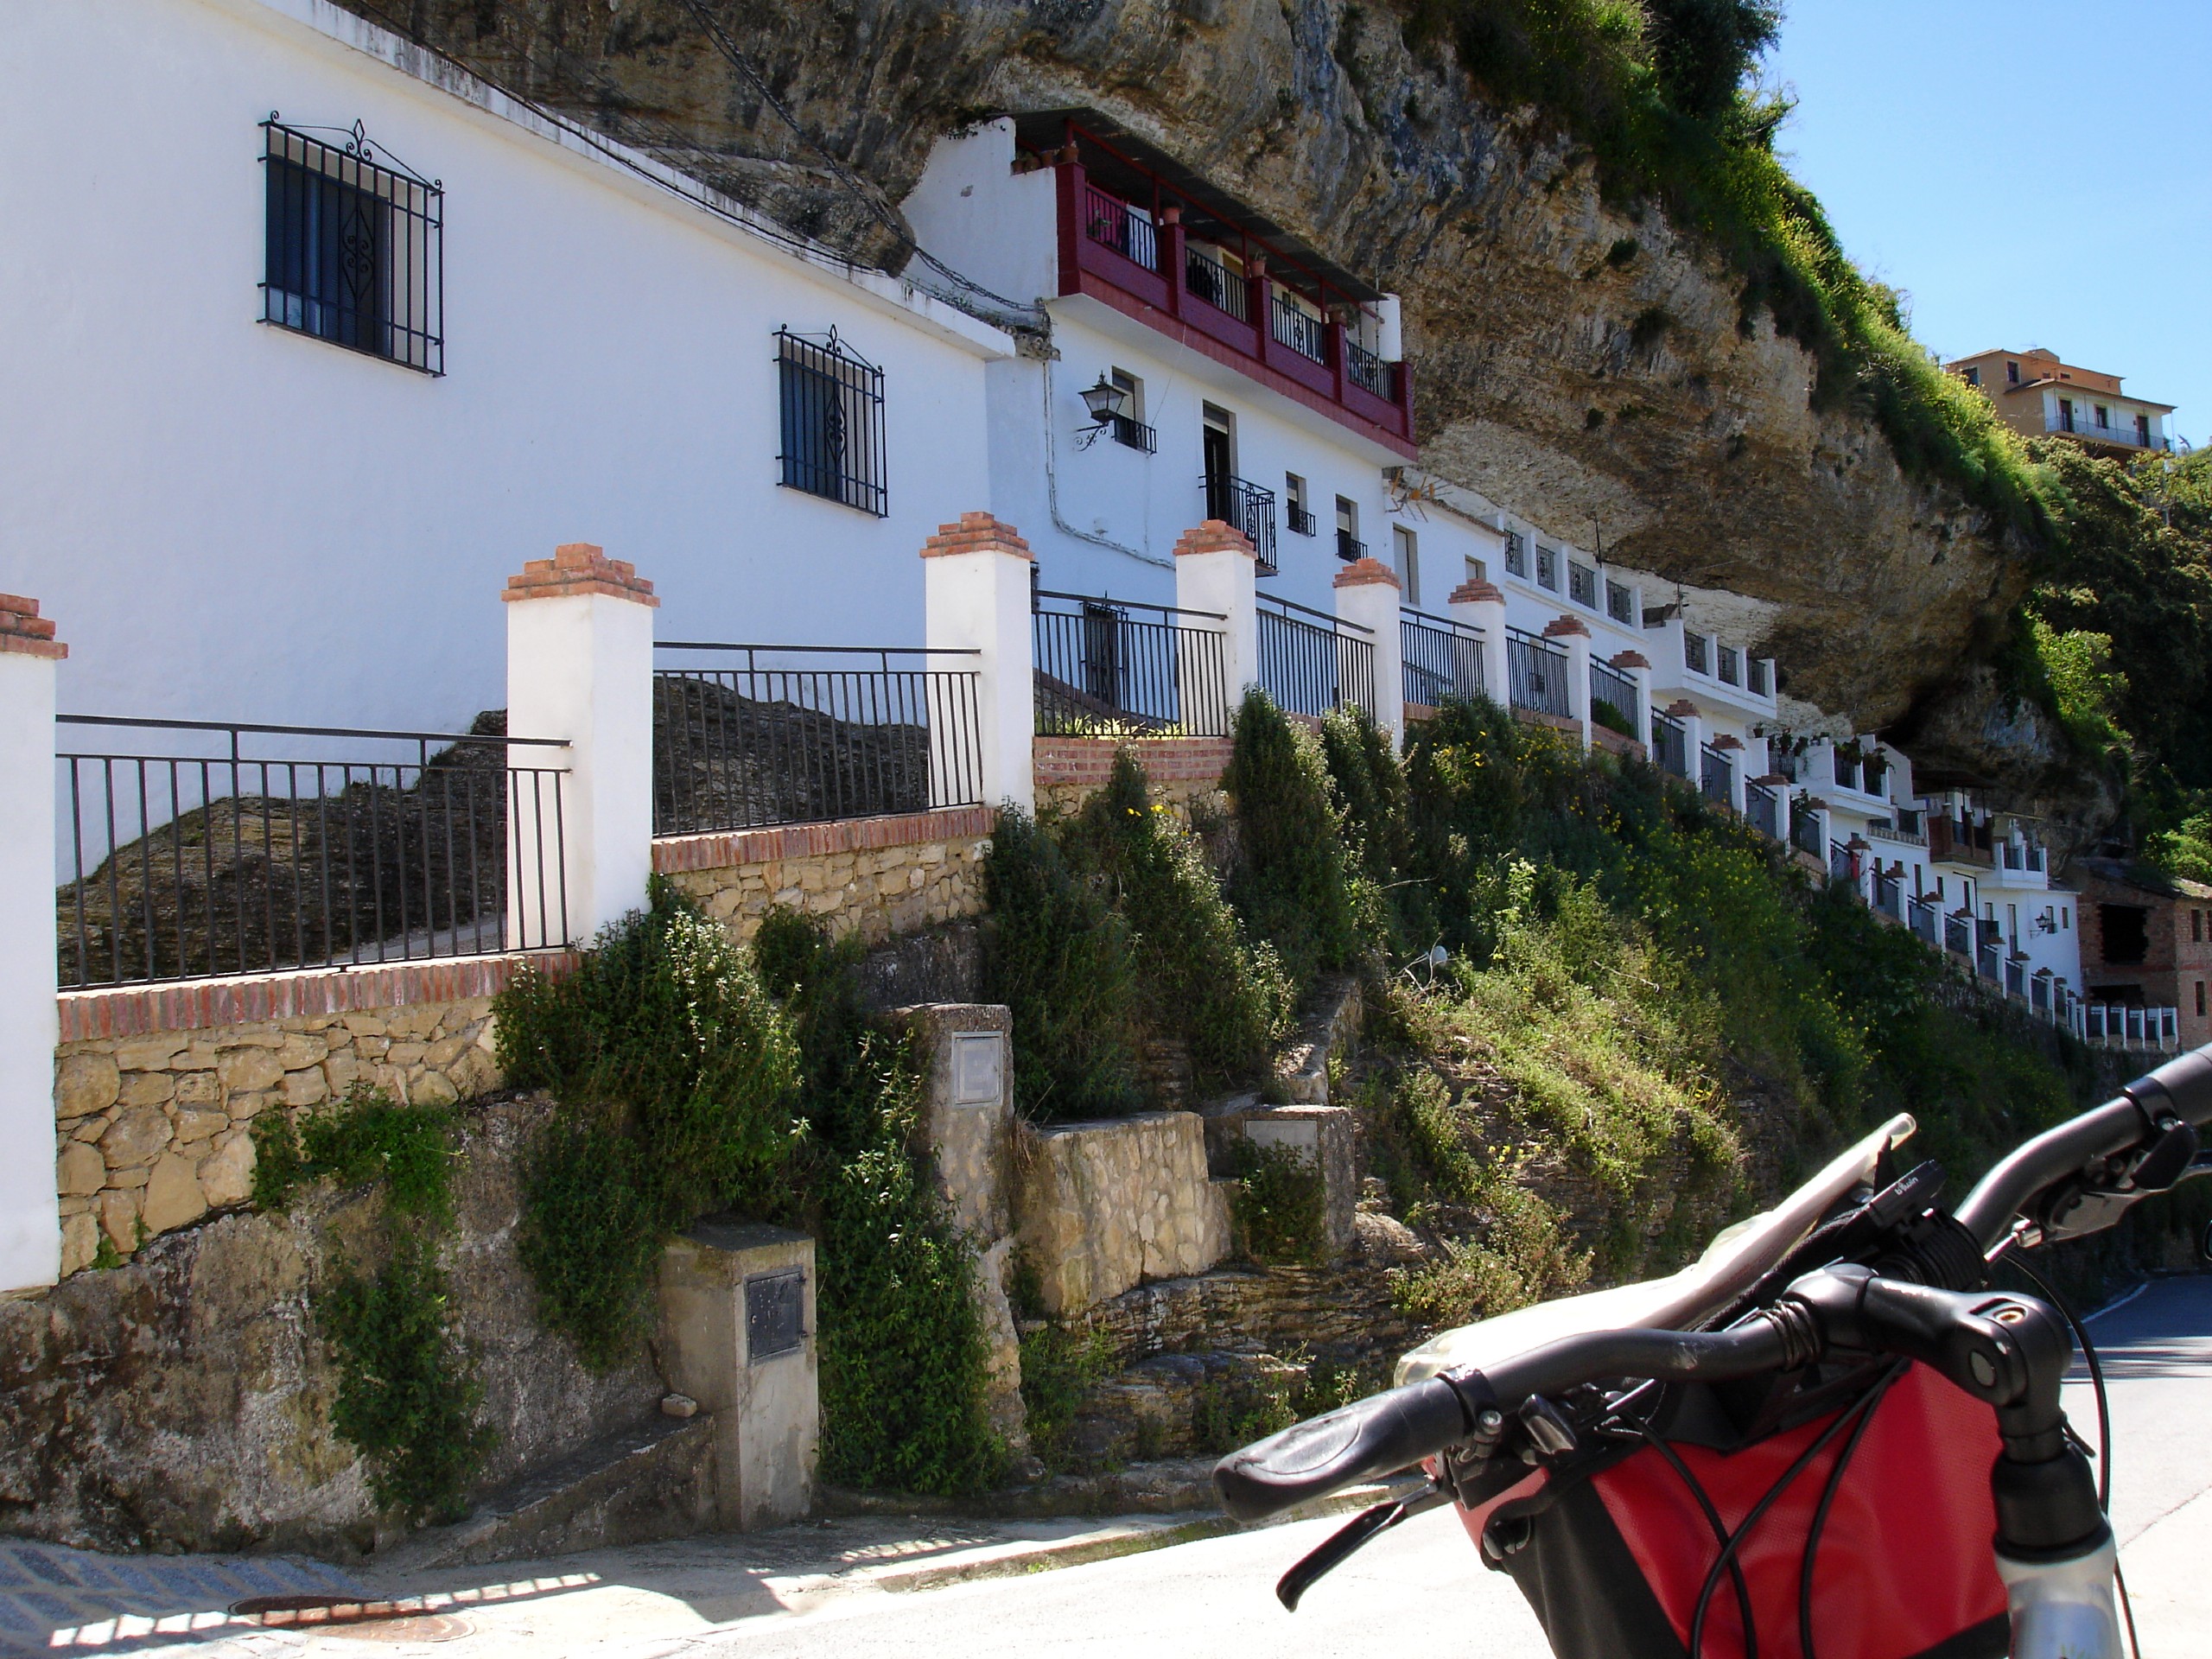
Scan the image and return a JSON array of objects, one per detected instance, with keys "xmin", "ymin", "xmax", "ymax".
[{"xmin": 1068, "ymin": 750, "xmax": 1292, "ymax": 1084}]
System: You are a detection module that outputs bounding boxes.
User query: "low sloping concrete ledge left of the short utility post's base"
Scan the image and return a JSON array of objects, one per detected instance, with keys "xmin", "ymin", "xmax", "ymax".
[{"xmin": 376, "ymin": 1415, "xmax": 715, "ymax": 1575}]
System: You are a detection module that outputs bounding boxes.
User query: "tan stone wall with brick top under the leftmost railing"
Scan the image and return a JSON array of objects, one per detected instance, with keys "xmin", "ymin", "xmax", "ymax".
[{"xmin": 53, "ymin": 953, "xmax": 575, "ymax": 1274}]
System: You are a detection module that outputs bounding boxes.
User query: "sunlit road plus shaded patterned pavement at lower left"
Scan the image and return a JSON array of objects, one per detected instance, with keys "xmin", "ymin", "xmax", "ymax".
[{"xmin": 13, "ymin": 1276, "xmax": 2212, "ymax": 1659}]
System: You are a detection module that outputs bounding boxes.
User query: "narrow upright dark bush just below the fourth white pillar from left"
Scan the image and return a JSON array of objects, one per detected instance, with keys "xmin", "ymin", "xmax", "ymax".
[{"xmin": 1221, "ymin": 686, "xmax": 1360, "ymax": 987}]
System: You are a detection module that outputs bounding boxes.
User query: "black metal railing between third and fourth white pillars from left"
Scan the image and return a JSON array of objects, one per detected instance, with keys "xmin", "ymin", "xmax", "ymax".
[{"xmin": 1031, "ymin": 588, "xmax": 1230, "ymax": 736}]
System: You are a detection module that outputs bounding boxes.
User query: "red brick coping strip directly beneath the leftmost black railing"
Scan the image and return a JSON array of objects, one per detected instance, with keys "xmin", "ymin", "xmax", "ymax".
[{"xmin": 60, "ymin": 951, "xmax": 577, "ymax": 1042}]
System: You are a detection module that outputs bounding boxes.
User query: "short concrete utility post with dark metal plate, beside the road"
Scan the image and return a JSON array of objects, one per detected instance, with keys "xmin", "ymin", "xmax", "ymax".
[{"xmin": 659, "ymin": 1217, "xmax": 821, "ymax": 1533}]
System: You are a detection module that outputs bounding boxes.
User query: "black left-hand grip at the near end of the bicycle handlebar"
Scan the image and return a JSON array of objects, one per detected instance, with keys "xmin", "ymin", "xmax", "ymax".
[{"xmin": 1214, "ymin": 1376, "xmax": 1473, "ymax": 1522}]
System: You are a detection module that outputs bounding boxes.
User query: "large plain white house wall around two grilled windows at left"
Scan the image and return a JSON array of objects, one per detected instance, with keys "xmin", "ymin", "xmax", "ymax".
[{"xmin": 0, "ymin": 0, "xmax": 1011, "ymax": 747}]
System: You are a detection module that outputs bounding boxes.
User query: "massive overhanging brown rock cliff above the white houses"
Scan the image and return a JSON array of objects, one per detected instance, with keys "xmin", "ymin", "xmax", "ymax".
[{"xmin": 345, "ymin": 0, "xmax": 2099, "ymax": 818}]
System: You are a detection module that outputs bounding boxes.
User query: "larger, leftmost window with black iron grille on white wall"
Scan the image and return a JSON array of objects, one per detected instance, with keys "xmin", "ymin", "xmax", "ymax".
[{"xmin": 261, "ymin": 115, "xmax": 445, "ymax": 374}]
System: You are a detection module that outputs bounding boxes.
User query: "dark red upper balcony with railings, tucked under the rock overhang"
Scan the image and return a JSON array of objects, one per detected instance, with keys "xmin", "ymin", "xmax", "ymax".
[{"xmin": 1033, "ymin": 122, "xmax": 1415, "ymax": 458}]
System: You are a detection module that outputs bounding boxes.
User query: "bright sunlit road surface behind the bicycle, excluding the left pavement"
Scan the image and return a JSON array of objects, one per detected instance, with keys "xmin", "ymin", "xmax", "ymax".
[{"xmin": 658, "ymin": 1276, "xmax": 2212, "ymax": 1659}]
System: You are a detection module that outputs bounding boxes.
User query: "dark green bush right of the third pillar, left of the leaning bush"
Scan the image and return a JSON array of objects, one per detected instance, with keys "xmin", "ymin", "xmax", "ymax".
[{"xmin": 982, "ymin": 807, "xmax": 1144, "ymax": 1122}]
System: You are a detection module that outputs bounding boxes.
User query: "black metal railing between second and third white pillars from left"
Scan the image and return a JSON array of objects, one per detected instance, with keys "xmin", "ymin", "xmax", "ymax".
[{"xmin": 652, "ymin": 641, "xmax": 982, "ymax": 836}]
